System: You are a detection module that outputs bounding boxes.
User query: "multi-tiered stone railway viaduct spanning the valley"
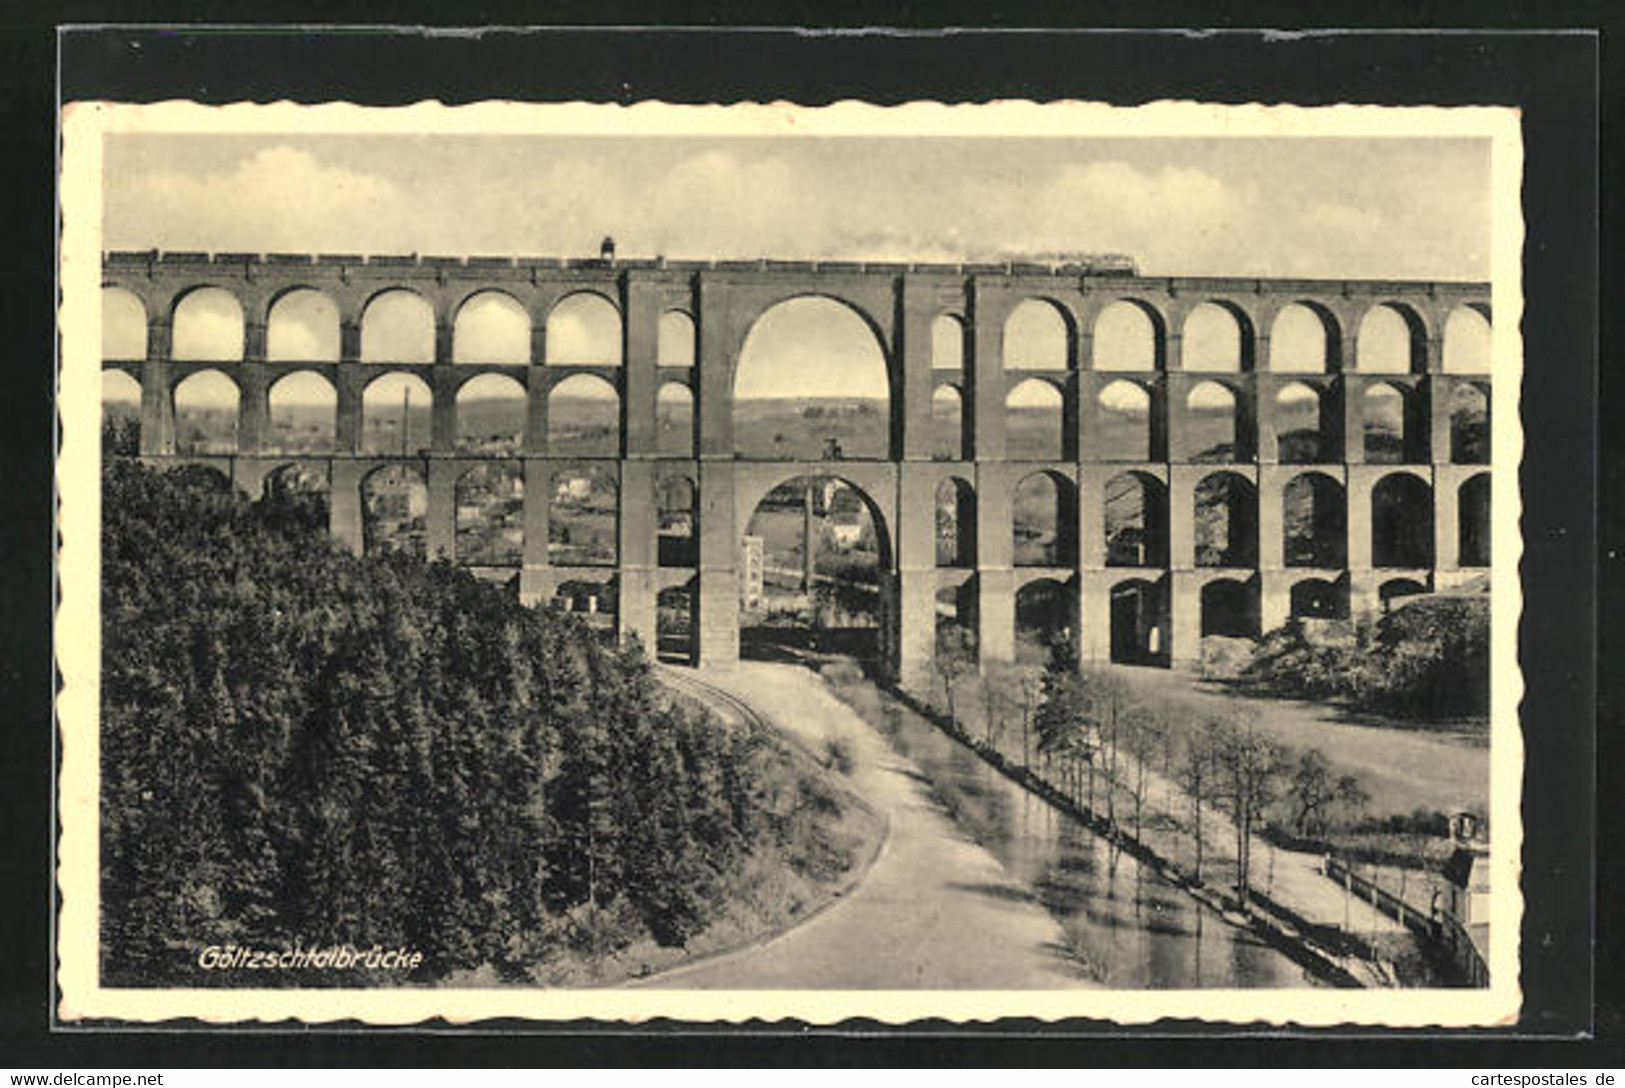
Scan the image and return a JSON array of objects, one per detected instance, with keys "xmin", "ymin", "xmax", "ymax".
[{"xmin": 102, "ymin": 252, "xmax": 1490, "ymax": 679}]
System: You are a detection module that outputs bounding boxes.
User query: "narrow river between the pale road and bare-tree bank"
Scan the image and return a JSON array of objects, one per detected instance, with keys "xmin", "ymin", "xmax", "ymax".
[{"xmin": 840, "ymin": 684, "xmax": 1315, "ymax": 989}]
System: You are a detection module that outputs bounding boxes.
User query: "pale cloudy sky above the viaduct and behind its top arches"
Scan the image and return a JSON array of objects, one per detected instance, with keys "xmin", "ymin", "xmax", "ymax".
[{"xmin": 104, "ymin": 133, "xmax": 1490, "ymax": 407}]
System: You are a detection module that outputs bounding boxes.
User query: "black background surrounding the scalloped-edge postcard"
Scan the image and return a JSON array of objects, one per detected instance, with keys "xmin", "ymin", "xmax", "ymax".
[{"xmin": 0, "ymin": 14, "xmax": 1599, "ymax": 1070}]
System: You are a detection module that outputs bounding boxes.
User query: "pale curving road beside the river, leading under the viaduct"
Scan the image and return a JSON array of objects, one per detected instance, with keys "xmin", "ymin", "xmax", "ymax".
[{"xmin": 639, "ymin": 663, "xmax": 1097, "ymax": 989}]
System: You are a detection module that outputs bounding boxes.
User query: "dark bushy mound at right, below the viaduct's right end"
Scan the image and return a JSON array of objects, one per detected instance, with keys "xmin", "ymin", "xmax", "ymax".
[{"xmin": 1240, "ymin": 594, "xmax": 1490, "ymax": 721}]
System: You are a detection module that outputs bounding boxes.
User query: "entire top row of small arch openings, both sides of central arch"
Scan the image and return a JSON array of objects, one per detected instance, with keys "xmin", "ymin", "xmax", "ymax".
[{"xmin": 102, "ymin": 287, "xmax": 1490, "ymax": 373}]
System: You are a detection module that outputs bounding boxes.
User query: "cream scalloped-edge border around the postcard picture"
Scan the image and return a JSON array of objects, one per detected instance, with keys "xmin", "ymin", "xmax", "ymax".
[{"xmin": 52, "ymin": 101, "xmax": 1524, "ymax": 1028}]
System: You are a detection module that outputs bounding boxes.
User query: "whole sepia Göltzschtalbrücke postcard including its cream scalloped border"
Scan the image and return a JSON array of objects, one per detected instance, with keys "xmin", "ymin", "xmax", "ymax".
[{"xmin": 59, "ymin": 104, "xmax": 1523, "ymax": 1025}]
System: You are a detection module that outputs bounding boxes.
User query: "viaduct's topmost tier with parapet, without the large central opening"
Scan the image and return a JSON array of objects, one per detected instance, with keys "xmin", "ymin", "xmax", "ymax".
[{"xmin": 104, "ymin": 255, "xmax": 1490, "ymax": 373}]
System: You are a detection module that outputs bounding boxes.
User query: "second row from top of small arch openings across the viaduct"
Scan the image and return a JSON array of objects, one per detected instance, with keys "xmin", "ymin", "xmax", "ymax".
[{"xmin": 102, "ymin": 369, "xmax": 1490, "ymax": 464}]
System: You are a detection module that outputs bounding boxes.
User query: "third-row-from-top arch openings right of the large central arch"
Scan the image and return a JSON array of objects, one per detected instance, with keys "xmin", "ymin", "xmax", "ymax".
[{"xmin": 936, "ymin": 471, "xmax": 1490, "ymax": 570}]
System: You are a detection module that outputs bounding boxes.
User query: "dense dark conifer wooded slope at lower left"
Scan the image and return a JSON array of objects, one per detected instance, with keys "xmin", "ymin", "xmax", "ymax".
[{"xmin": 101, "ymin": 463, "xmax": 850, "ymax": 984}]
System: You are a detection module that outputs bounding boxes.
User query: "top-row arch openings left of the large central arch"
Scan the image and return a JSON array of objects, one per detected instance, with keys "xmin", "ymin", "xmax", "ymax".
[{"xmin": 102, "ymin": 287, "xmax": 696, "ymax": 367}]
